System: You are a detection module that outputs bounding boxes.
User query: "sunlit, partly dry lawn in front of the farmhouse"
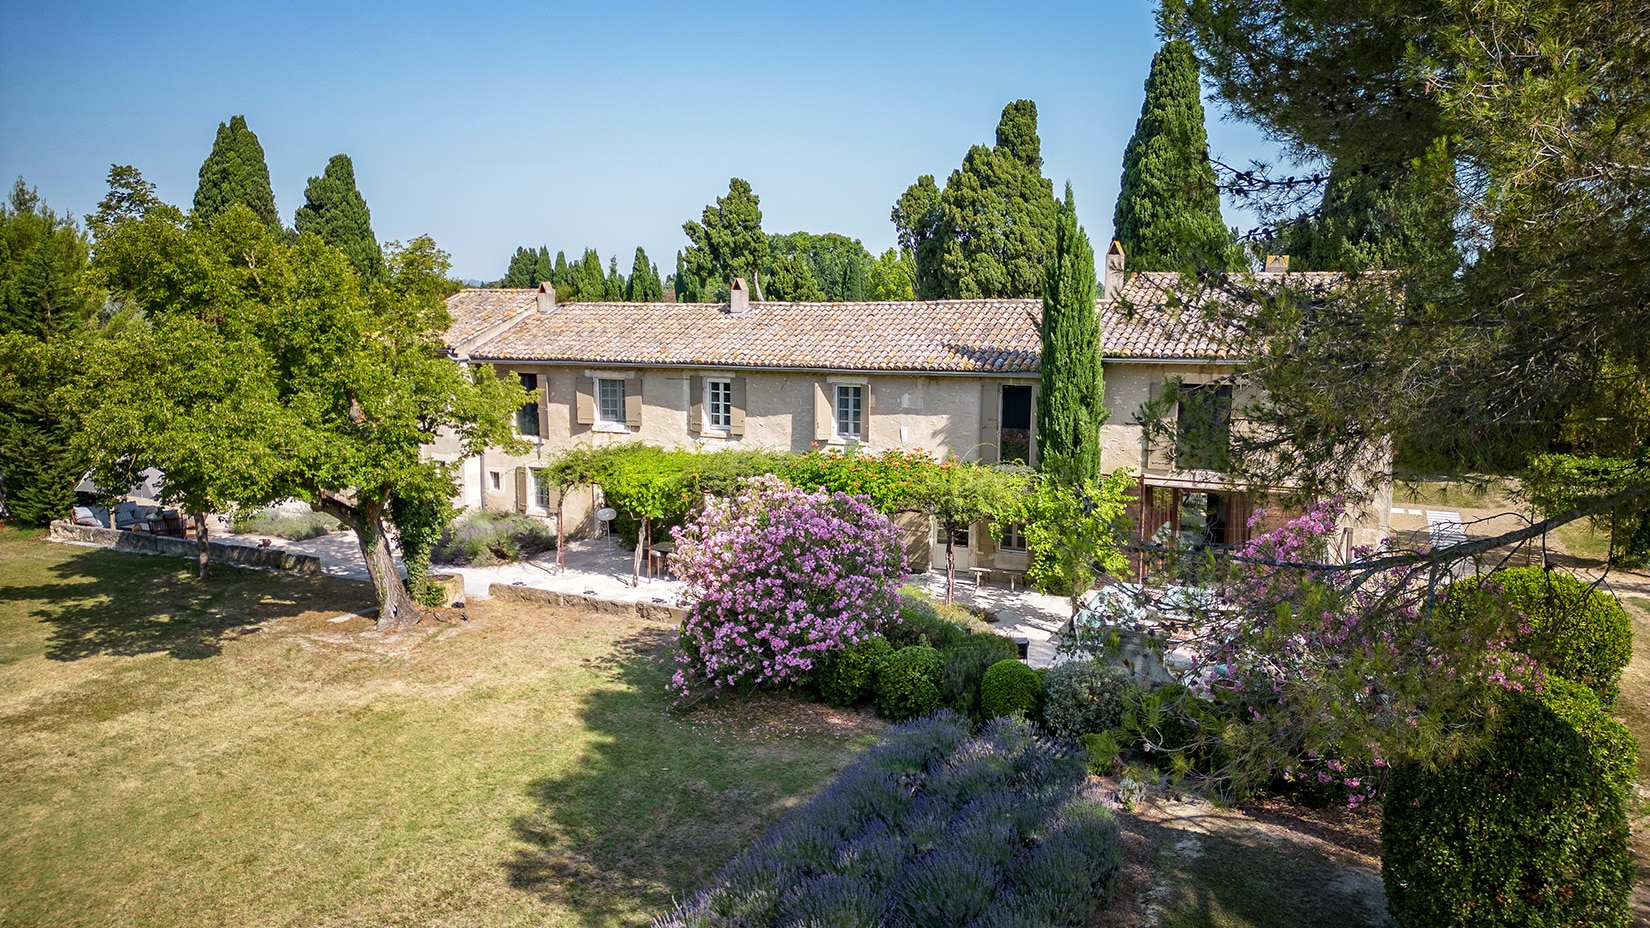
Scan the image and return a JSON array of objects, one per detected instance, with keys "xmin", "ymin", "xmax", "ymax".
[{"xmin": 0, "ymin": 530, "xmax": 878, "ymax": 926}]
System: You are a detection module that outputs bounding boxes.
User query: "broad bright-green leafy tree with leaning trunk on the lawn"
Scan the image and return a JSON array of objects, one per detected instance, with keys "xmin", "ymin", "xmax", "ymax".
[{"xmin": 74, "ymin": 193, "xmax": 523, "ymax": 627}]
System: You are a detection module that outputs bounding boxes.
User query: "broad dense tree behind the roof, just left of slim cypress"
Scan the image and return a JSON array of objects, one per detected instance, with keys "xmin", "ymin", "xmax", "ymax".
[{"xmin": 891, "ymin": 99, "xmax": 1054, "ymax": 299}]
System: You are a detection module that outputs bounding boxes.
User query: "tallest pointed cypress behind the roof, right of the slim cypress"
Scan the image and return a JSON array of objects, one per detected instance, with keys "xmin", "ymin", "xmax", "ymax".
[{"xmin": 1112, "ymin": 40, "xmax": 1238, "ymax": 271}]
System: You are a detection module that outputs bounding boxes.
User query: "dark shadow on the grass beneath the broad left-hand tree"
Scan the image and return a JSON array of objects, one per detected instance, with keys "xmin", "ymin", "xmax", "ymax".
[{"xmin": 3, "ymin": 550, "xmax": 375, "ymax": 660}]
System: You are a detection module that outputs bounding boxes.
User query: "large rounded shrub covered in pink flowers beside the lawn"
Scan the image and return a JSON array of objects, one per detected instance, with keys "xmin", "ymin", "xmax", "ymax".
[{"xmin": 672, "ymin": 476, "xmax": 906, "ymax": 703}]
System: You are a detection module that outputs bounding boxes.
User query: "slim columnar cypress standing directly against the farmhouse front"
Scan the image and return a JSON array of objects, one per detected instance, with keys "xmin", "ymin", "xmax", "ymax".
[{"xmin": 1036, "ymin": 183, "xmax": 1106, "ymax": 484}]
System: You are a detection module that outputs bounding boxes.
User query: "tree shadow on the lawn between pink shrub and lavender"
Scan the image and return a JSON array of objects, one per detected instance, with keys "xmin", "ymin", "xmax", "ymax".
[{"xmin": 505, "ymin": 627, "xmax": 881, "ymax": 925}]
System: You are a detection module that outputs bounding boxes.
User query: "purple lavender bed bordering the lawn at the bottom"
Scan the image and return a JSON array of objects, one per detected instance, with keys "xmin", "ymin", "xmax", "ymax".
[{"xmin": 653, "ymin": 712, "xmax": 1122, "ymax": 928}]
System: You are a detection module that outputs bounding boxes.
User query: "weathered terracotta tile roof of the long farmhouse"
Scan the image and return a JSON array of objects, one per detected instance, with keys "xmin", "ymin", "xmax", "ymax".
[{"xmin": 449, "ymin": 272, "xmax": 1338, "ymax": 375}]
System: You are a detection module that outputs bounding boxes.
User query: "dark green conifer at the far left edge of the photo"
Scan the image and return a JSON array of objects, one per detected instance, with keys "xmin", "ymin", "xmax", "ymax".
[{"xmin": 0, "ymin": 180, "xmax": 95, "ymax": 525}]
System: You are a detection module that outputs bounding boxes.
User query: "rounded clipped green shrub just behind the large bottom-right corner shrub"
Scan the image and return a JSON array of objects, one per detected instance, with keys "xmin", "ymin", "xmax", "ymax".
[{"xmin": 1444, "ymin": 566, "xmax": 1634, "ymax": 705}]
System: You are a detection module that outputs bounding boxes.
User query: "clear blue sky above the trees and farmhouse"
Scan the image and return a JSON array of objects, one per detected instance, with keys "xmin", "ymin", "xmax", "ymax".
[{"xmin": 0, "ymin": 0, "xmax": 1272, "ymax": 279}]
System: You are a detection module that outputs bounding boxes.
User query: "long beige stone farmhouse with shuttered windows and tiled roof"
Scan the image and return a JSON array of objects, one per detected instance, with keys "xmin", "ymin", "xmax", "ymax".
[{"xmin": 429, "ymin": 244, "xmax": 1391, "ymax": 573}]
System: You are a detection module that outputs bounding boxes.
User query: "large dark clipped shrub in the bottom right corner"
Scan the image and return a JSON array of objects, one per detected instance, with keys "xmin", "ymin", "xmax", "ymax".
[{"xmin": 1381, "ymin": 679, "xmax": 1637, "ymax": 928}]
